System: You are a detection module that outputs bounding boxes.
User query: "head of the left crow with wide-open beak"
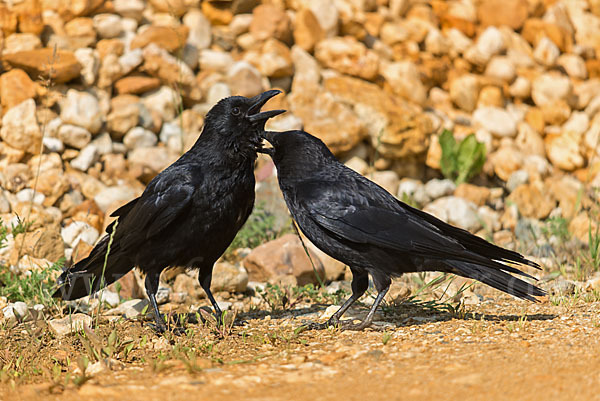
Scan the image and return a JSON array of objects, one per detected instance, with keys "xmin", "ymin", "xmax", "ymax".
[{"xmin": 201, "ymin": 89, "xmax": 285, "ymax": 155}]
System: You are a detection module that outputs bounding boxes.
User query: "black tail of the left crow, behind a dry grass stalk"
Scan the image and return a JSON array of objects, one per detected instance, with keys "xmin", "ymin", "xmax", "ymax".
[{"xmin": 53, "ymin": 235, "xmax": 133, "ymax": 300}]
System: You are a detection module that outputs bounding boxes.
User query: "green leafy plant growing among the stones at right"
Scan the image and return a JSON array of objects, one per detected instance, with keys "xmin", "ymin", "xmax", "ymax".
[{"xmin": 439, "ymin": 130, "xmax": 486, "ymax": 184}]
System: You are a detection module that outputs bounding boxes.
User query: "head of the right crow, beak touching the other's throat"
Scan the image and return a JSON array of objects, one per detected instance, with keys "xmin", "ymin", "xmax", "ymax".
[{"xmin": 260, "ymin": 131, "xmax": 337, "ymax": 174}]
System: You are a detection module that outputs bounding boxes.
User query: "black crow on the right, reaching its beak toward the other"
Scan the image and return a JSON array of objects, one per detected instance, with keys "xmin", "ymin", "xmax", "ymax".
[{"xmin": 263, "ymin": 131, "xmax": 545, "ymax": 329}]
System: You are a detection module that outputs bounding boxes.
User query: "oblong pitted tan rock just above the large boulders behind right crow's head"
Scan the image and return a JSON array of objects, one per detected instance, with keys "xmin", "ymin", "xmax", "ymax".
[{"xmin": 315, "ymin": 37, "xmax": 379, "ymax": 80}]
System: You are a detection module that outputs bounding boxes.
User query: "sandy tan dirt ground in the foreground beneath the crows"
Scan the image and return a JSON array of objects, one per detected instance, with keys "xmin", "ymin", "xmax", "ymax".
[{"xmin": 0, "ymin": 295, "xmax": 600, "ymax": 401}]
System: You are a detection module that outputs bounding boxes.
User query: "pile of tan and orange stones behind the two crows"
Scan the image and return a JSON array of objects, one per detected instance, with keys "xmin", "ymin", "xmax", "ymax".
[{"xmin": 0, "ymin": 0, "xmax": 600, "ymax": 316}]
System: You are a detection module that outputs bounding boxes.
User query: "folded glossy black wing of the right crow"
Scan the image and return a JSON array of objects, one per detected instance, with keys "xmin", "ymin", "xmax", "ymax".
[{"xmin": 296, "ymin": 179, "xmax": 530, "ymax": 277}]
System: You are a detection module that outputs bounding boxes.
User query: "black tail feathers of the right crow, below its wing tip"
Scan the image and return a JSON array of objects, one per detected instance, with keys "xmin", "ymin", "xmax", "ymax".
[{"xmin": 446, "ymin": 261, "xmax": 546, "ymax": 302}]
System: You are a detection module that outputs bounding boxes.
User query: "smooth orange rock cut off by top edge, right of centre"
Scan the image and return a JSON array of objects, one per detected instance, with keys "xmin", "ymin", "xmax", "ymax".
[{"xmin": 477, "ymin": 0, "xmax": 529, "ymax": 30}]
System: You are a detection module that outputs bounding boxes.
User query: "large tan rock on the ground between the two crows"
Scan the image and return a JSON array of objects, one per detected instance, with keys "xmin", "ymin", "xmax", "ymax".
[{"xmin": 243, "ymin": 234, "xmax": 325, "ymax": 285}]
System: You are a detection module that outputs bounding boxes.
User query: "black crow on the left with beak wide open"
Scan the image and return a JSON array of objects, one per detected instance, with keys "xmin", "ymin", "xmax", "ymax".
[{"xmin": 54, "ymin": 90, "xmax": 284, "ymax": 331}]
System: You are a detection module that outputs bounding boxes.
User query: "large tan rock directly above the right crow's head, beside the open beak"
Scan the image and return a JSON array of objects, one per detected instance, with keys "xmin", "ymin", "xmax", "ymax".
[{"xmin": 288, "ymin": 86, "xmax": 364, "ymax": 153}]
